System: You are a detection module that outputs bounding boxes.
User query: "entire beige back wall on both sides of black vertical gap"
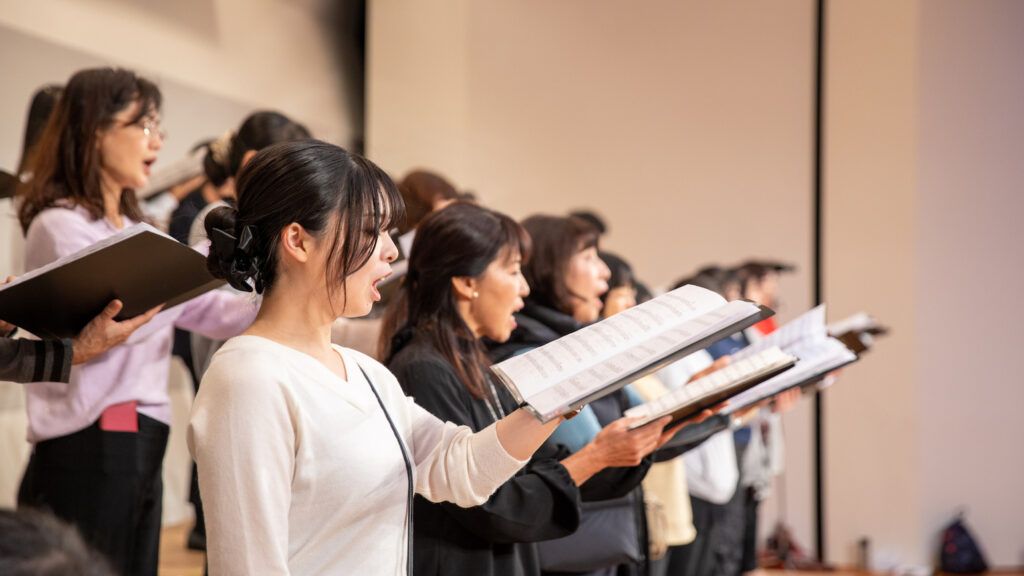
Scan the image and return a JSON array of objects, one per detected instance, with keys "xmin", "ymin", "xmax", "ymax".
[{"xmin": 368, "ymin": 0, "xmax": 1024, "ymax": 568}]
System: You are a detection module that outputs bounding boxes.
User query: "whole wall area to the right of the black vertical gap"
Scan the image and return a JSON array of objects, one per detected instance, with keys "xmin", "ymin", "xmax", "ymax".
[{"xmin": 825, "ymin": 0, "xmax": 1024, "ymax": 568}]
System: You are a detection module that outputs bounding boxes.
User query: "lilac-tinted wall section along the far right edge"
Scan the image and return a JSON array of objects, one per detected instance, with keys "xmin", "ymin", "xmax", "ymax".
[{"xmin": 915, "ymin": 0, "xmax": 1024, "ymax": 567}]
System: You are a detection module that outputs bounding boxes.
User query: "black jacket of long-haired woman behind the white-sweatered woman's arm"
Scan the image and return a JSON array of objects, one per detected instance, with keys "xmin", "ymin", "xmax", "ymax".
[{"xmin": 388, "ymin": 333, "xmax": 580, "ymax": 576}]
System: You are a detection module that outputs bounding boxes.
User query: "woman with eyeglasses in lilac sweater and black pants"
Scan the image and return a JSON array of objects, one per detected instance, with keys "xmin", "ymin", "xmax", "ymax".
[{"xmin": 18, "ymin": 68, "xmax": 256, "ymax": 575}]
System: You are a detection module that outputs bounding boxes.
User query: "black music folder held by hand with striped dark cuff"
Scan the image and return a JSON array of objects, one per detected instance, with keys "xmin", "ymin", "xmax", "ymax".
[{"xmin": 0, "ymin": 223, "xmax": 224, "ymax": 338}]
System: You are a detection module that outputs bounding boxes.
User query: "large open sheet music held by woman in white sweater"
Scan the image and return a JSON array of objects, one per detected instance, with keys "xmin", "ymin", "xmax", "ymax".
[{"xmin": 492, "ymin": 286, "xmax": 773, "ymax": 422}]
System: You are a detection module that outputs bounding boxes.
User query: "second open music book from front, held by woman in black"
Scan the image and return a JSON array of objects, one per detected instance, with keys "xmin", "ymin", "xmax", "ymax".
[{"xmin": 626, "ymin": 346, "xmax": 797, "ymax": 428}]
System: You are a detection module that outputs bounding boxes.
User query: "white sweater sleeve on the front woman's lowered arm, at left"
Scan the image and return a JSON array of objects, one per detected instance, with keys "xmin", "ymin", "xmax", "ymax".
[{"xmin": 188, "ymin": 358, "xmax": 296, "ymax": 575}]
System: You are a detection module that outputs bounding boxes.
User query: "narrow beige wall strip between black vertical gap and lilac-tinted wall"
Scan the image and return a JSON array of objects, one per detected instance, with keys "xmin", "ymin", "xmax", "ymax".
[{"xmin": 824, "ymin": 0, "xmax": 926, "ymax": 567}]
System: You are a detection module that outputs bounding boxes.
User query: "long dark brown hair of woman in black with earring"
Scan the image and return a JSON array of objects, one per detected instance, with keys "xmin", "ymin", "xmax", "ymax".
[{"xmin": 380, "ymin": 202, "xmax": 529, "ymax": 398}]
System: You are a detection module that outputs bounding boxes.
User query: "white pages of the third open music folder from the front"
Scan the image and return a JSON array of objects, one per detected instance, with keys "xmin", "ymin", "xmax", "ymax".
[{"xmin": 722, "ymin": 336, "xmax": 857, "ymax": 414}]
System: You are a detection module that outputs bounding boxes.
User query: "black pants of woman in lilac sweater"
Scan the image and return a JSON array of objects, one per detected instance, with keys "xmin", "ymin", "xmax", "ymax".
[{"xmin": 18, "ymin": 414, "xmax": 170, "ymax": 576}]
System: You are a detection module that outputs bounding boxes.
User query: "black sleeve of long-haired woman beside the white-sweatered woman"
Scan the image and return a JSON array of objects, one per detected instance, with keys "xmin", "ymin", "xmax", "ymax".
[{"xmin": 395, "ymin": 362, "xmax": 580, "ymax": 542}]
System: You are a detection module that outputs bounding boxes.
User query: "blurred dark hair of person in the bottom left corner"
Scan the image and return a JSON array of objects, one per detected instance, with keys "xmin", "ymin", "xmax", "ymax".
[{"xmin": 0, "ymin": 509, "xmax": 114, "ymax": 576}]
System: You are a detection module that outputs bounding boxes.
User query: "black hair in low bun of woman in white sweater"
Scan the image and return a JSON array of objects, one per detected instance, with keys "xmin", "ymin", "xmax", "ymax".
[{"xmin": 204, "ymin": 139, "xmax": 404, "ymax": 303}]
